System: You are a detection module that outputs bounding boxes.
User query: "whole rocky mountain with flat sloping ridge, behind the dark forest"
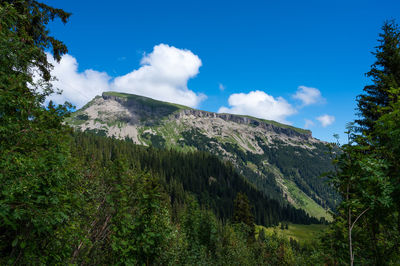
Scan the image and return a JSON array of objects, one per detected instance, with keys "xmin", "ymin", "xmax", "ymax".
[{"xmin": 66, "ymin": 92, "xmax": 337, "ymax": 220}]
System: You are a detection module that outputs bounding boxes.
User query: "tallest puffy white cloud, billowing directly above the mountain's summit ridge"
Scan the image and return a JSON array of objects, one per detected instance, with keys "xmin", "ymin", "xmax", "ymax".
[{"xmin": 111, "ymin": 44, "xmax": 206, "ymax": 107}]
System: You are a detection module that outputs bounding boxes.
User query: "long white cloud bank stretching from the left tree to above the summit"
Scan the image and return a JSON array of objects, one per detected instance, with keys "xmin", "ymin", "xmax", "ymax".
[{"xmin": 48, "ymin": 44, "xmax": 207, "ymax": 108}]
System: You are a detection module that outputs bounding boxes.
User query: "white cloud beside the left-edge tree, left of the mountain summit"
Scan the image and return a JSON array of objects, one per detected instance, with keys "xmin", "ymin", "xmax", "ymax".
[{"xmin": 47, "ymin": 54, "xmax": 111, "ymax": 108}]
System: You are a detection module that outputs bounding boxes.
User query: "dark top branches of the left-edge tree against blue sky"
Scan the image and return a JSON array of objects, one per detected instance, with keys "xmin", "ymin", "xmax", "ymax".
[{"xmin": 0, "ymin": 0, "xmax": 71, "ymax": 81}]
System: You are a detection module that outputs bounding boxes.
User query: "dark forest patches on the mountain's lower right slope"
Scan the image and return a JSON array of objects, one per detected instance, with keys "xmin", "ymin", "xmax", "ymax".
[{"xmin": 178, "ymin": 125, "xmax": 340, "ymax": 210}]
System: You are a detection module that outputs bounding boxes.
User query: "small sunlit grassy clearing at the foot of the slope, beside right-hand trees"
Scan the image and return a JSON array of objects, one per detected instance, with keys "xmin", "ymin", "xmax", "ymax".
[{"xmin": 256, "ymin": 223, "xmax": 327, "ymax": 243}]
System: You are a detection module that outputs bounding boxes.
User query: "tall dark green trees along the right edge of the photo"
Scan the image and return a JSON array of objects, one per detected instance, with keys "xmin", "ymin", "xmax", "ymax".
[{"xmin": 325, "ymin": 19, "xmax": 400, "ymax": 265}]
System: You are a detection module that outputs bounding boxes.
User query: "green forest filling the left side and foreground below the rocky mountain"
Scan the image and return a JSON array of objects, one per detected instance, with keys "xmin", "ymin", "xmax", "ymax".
[{"xmin": 0, "ymin": 0, "xmax": 324, "ymax": 265}]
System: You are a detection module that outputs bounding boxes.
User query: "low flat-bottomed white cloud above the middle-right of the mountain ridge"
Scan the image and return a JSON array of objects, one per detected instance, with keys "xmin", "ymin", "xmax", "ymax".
[{"xmin": 218, "ymin": 90, "xmax": 297, "ymax": 124}]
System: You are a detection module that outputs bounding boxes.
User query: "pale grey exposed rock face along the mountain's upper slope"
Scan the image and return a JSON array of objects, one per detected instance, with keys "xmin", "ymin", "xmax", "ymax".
[{"xmin": 67, "ymin": 93, "xmax": 334, "ymax": 220}]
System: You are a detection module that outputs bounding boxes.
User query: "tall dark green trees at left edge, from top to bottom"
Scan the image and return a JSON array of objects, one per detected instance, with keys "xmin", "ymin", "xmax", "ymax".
[{"xmin": 0, "ymin": 1, "xmax": 76, "ymax": 264}]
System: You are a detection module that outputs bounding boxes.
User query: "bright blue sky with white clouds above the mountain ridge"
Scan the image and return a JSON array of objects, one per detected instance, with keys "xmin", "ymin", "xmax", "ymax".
[{"xmin": 45, "ymin": 0, "xmax": 400, "ymax": 141}]
